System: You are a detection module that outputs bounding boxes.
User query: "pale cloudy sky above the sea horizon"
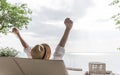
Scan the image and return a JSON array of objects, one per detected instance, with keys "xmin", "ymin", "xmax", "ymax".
[{"xmin": 0, "ymin": 0, "xmax": 120, "ymax": 55}]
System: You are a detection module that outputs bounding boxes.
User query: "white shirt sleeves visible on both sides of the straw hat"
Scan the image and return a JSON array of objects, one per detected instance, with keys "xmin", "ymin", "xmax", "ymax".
[{"xmin": 24, "ymin": 45, "xmax": 65, "ymax": 60}]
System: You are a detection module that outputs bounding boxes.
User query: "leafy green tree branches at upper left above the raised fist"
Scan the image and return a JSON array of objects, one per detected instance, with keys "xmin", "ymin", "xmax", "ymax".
[{"xmin": 0, "ymin": 0, "xmax": 32, "ymax": 34}]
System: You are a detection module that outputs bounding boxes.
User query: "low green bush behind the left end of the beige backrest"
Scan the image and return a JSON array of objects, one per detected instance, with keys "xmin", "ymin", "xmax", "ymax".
[{"xmin": 0, "ymin": 47, "xmax": 19, "ymax": 57}]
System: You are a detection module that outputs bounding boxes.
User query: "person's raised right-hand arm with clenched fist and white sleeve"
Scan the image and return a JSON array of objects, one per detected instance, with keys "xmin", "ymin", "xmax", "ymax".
[{"xmin": 54, "ymin": 18, "xmax": 73, "ymax": 60}]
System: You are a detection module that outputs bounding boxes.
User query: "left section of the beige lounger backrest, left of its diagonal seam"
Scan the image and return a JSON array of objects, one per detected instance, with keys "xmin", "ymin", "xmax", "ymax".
[{"xmin": 0, "ymin": 57, "xmax": 23, "ymax": 75}]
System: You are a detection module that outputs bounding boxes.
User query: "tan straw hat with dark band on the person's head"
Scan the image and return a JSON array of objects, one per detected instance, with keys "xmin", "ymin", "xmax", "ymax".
[{"xmin": 31, "ymin": 44, "xmax": 51, "ymax": 59}]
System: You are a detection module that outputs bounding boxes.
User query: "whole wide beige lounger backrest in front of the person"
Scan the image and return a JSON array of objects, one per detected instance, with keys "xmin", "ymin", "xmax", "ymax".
[{"xmin": 0, "ymin": 58, "xmax": 68, "ymax": 75}]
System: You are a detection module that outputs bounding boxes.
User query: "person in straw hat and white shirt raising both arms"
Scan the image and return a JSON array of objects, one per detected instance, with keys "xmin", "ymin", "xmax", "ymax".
[{"xmin": 12, "ymin": 18, "xmax": 73, "ymax": 60}]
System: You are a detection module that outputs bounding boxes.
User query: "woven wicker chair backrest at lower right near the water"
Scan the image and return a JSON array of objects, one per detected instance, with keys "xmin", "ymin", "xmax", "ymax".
[{"xmin": 89, "ymin": 62, "xmax": 106, "ymax": 75}]
